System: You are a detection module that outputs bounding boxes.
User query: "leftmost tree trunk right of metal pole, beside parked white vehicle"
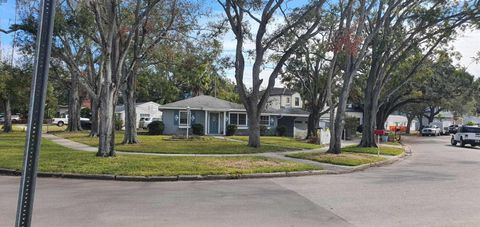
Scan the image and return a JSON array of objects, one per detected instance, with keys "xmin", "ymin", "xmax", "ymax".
[{"xmin": 67, "ymin": 73, "xmax": 82, "ymax": 132}]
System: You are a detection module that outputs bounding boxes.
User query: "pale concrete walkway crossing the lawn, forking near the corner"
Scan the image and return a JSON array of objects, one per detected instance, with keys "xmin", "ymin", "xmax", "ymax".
[{"xmin": 43, "ymin": 134, "xmax": 398, "ymax": 172}]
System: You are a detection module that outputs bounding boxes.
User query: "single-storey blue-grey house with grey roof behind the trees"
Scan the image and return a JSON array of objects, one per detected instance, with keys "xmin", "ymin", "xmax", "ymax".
[{"xmin": 159, "ymin": 95, "xmax": 308, "ymax": 136}]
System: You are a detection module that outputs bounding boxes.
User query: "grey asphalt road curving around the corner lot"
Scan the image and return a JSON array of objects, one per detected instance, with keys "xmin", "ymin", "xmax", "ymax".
[{"xmin": 0, "ymin": 136, "xmax": 480, "ymax": 227}]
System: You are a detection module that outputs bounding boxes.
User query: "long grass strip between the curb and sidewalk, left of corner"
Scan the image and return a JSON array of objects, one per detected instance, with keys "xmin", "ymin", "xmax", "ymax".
[{"xmin": 0, "ymin": 132, "xmax": 319, "ymax": 176}]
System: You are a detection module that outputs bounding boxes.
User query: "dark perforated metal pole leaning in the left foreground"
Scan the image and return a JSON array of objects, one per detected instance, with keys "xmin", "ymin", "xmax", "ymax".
[{"xmin": 15, "ymin": 0, "xmax": 55, "ymax": 227}]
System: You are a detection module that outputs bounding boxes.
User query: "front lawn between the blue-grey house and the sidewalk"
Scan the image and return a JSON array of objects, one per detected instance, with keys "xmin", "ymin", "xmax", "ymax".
[{"xmin": 55, "ymin": 132, "xmax": 304, "ymax": 154}]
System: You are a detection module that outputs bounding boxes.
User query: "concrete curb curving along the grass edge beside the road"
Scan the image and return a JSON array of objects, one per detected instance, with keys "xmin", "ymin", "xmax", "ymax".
[{"xmin": 0, "ymin": 146, "xmax": 411, "ymax": 182}]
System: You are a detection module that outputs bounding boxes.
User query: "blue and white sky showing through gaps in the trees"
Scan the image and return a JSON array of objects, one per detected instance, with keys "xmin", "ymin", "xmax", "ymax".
[{"xmin": 0, "ymin": 0, "xmax": 480, "ymax": 87}]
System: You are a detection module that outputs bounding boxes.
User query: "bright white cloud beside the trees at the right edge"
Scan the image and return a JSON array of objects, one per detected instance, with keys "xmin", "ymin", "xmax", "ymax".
[{"xmin": 453, "ymin": 30, "xmax": 480, "ymax": 78}]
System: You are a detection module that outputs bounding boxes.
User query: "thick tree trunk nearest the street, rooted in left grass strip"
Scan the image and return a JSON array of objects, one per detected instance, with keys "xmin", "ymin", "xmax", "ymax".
[{"xmin": 97, "ymin": 82, "xmax": 116, "ymax": 157}]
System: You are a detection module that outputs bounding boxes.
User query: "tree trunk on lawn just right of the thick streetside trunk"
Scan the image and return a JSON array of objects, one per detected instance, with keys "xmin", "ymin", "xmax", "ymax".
[{"xmin": 122, "ymin": 74, "xmax": 139, "ymax": 144}]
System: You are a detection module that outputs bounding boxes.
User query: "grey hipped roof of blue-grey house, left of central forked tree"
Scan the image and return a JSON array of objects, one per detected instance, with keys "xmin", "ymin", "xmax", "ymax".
[{"xmin": 160, "ymin": 95, "xmax": 245, "ymax": 110}]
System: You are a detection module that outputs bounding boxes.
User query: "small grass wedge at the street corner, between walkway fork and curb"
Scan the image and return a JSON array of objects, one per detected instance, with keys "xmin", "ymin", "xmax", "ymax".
[{"xmin": 287, "ymin": 152, "xmax": 385, "ymax": 166}]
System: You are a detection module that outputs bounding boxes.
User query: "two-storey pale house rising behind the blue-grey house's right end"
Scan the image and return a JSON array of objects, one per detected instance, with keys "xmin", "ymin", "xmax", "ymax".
[{"xmin": 266, "ymin": 87, "xmax": 303, "ymax": 109}]
